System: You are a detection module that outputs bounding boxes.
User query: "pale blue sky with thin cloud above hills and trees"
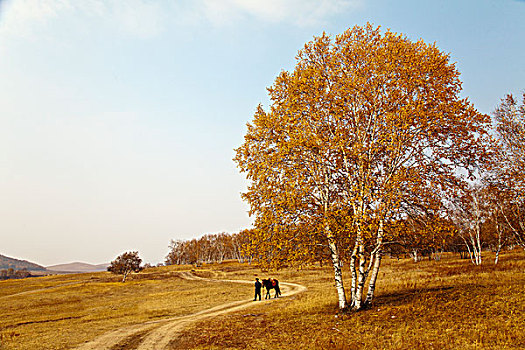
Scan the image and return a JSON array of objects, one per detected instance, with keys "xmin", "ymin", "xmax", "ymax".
[{"xmin": 0, "ymin": 0, "xmax": 525, "ymax": 265}]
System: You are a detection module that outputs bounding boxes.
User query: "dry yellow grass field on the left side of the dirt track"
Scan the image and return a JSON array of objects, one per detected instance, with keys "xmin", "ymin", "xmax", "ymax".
[{"xmin": 0, "ymin": 266, "xmax": 251, "ymax": 350}]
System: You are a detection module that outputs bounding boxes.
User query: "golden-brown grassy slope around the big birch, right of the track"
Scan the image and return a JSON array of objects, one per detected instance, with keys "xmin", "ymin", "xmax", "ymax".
[{"xmin": 172, "ymin": 252, "xmax": 525, "ymax": 349}]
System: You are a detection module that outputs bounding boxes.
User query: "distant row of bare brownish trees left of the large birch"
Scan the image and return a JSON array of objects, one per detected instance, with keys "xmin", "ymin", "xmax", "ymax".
[{"xmin": 165, "ymin": 230, "xmax": 252, "ymax": 265}]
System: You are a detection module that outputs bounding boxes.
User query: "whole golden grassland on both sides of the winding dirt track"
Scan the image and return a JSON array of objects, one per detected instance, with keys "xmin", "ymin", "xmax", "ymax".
[{"xmin": 0, "ymin": 251, "xmax": 525, "ymax": 350}]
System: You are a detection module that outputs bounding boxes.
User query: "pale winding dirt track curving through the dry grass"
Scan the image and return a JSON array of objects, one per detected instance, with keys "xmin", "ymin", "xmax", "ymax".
[{"xmin": 71, "ymin": 272, "xmax": 306, "ymax": 350}]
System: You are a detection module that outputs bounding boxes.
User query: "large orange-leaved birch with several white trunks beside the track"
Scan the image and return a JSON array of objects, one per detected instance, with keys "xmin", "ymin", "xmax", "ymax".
[{"xmin": 235, "ymin": 24, "xmax": 488, "ymax": 310}]
